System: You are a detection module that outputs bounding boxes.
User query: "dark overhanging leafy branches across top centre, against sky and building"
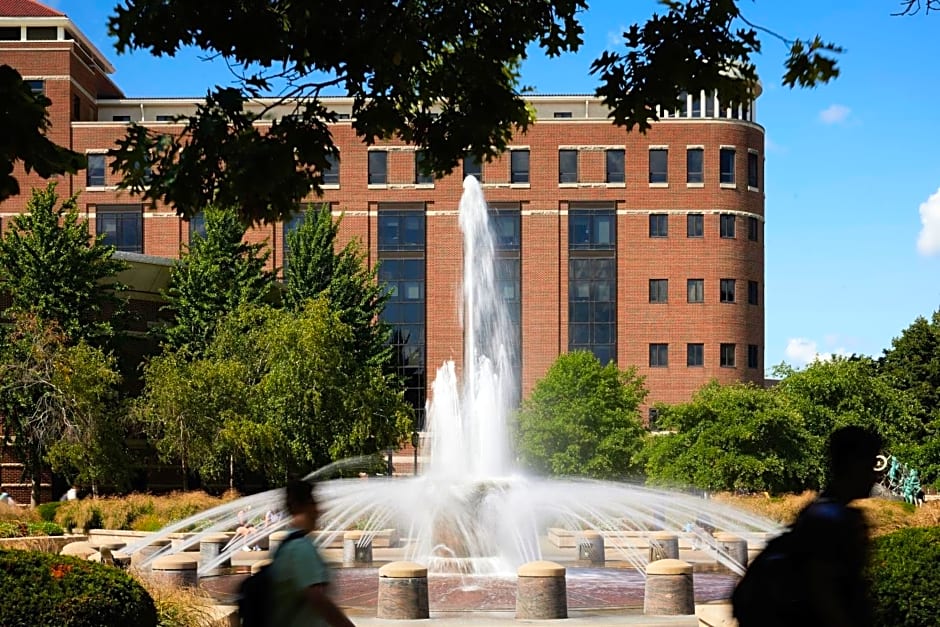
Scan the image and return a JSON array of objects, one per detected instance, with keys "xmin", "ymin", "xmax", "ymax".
[{"xmin": 108, "ymin": 0, "xmax": 860, "ymax": 222}]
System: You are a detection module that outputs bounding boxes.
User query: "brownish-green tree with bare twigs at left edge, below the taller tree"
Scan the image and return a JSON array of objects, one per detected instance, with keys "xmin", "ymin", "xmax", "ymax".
[{"xmin": 0, "ymin": 314, "xmax": 126, "ymax": 505}]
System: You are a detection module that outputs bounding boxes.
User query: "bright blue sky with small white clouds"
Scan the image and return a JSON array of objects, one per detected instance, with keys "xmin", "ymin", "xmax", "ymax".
[{"xmin": 46, "ymin": 0, "xmax": 940, "ymax": 367}]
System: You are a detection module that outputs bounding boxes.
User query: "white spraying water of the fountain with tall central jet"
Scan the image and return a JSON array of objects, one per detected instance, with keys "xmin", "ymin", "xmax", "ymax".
[{"xmin": 117, "ymin": 177, "xmax": 779, "ymax": 612}]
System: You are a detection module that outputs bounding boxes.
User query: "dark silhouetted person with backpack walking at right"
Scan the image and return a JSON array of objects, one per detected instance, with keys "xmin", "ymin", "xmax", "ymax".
[{"xmin": 732, "ymin": 426, "xmax": 881, "ymax": 627}]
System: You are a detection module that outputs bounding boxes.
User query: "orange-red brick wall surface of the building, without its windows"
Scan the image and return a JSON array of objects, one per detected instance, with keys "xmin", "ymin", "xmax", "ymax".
[{"xmin": 0, "ymin": 4, "xmax": 764, "ymax": 424}]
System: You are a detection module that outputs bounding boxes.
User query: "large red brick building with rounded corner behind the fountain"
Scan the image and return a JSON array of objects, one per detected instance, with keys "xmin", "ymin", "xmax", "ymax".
[{"xmin": 0, "ymin": 0, "xmax": 764, "ymax": 436}]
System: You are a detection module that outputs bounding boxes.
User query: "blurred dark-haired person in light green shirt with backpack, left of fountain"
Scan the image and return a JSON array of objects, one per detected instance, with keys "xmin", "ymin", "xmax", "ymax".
[{"xmin": 268, "ymin": 479, "xmax": 353, "ymax": 627}]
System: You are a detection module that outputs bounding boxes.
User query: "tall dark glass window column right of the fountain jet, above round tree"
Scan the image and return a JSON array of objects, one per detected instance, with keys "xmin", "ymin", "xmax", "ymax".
[{"xmin": 568, "ymin": 208, "xmax": 617, "ymax": 365}]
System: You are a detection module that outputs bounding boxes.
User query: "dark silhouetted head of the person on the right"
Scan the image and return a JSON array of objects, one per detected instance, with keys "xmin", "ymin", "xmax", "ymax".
[{"xmin": 829, "ymin": 425, "xmax": 881, "ymax": 500}]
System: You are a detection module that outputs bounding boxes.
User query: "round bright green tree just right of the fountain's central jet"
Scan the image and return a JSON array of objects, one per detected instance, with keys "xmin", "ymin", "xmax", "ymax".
[{"xmin": 516, "ymin": 351, "xmax": 646, "ymax": 479}]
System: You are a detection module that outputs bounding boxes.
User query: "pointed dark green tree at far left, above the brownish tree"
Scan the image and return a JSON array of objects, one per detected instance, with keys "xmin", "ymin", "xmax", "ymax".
[{"xmin": 0, "ymin": 183, "xmax": 127, "ymax": 342}]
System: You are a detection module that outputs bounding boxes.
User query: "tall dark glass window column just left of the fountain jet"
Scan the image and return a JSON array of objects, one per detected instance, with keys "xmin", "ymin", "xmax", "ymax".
[{"xmin": 378, "ymin": 203, "xmax": 427, "ymax": 430}]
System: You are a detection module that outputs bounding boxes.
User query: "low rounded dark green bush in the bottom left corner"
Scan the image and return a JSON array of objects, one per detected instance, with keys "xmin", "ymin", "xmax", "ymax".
[{"xmin": 0, "ymin": 550, "xmax": 157, "ymax": 627}]
